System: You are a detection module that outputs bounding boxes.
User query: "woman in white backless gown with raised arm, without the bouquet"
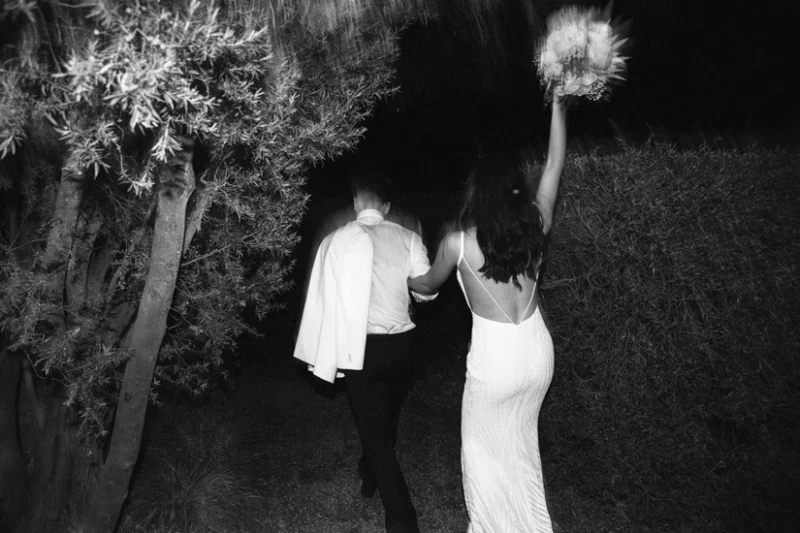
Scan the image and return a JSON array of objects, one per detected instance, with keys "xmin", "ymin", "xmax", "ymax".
[{"xmin": 408, "ymin": 96, "xmax": 566, "ymax": 533}]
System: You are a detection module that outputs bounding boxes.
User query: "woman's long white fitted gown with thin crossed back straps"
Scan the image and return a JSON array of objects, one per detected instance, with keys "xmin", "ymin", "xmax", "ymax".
[{"xmin": 456, "ymin": 234, "xmax": 553, "ymax": 533}]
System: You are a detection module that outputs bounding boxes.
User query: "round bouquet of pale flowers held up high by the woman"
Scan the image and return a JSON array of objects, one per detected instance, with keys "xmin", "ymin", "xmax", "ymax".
[{"xmin": 538, "ymin": 6, "xmax": 628, "ymax": 100}]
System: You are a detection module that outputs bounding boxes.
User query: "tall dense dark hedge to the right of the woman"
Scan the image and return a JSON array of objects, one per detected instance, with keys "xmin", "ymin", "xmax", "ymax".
[{"xmin": 542, "ymin": 140, "xmax": 800, "ymax": 530}]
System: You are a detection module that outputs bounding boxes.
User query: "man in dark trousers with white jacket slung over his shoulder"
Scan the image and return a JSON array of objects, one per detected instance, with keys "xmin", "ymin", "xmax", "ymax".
[{"xmin": 295, "ymin": 178, "xmax": 436, "ymax": 533}]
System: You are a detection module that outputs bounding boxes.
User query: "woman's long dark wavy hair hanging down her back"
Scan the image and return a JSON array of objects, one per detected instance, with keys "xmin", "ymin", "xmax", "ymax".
[{"xmin": 458, "ymin": 151, "xmax": 547, "ymax": 288}]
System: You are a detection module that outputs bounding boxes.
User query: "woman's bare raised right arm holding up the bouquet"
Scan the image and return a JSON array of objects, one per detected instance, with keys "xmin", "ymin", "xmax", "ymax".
[{"xmin": 529, "ymin": 94, "xmax": 567, "ymax": 233}]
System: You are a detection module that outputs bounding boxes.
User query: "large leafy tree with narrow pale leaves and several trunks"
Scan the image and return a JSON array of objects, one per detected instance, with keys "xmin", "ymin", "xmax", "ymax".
[{"xmin": 0, "ymin": 0, "xmax": 438, "ymax": 533}]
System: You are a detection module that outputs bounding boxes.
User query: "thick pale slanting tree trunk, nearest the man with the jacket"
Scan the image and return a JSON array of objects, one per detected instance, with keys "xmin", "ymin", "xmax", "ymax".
[{"xmin": 85, "ymin": 140, "xmax": 195, "ymax": 533}]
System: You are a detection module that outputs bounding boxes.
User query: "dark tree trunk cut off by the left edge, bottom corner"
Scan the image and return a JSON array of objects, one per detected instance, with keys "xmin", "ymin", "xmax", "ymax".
[{"xmin": 0, "ymin": 348, "xmax": 28, "ymax": 531}]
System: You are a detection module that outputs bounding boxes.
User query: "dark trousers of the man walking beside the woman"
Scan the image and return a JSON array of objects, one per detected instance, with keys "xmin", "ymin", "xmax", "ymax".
[{"xmin": 344, "ymin": 329, "xmax": 419, "ymax": 533}]
